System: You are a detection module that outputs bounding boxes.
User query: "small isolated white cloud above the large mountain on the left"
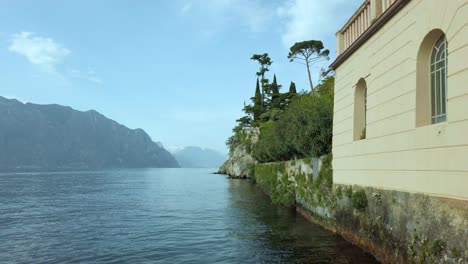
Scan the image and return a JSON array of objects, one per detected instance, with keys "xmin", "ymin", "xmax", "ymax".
[{"xmin": 8, "ymin": 32, "xmax": 70, "ymax": 72}]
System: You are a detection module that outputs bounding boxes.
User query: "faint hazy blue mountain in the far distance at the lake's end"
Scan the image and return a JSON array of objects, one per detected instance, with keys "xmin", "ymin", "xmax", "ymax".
[{"xmin": 173, "ymin": 147, "xmax": 227, "ymax": 168}]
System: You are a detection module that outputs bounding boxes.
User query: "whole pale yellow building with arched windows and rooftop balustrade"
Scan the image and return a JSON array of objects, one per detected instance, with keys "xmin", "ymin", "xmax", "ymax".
[{"xmin": 331, "ymin": 0, "xmax": 468, "ymax": 200}]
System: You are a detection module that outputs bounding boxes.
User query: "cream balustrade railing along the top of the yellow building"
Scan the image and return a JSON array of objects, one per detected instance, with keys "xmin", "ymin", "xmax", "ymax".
[{"xmin": 336, "ymin": 0, "xmax": 397, "ymax": 56}]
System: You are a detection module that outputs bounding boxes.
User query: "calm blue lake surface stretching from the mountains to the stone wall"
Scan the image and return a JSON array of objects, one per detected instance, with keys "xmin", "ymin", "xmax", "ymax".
[{"xmin": 0, "ymin": 169, "xmax": 377, "ymax": 264}]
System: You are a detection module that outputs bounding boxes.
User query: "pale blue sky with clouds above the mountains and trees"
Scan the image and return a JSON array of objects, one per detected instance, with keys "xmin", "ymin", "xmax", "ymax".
[{"xmin": 0, "ymin": 0, "xmax": 363, "ymax": 153}]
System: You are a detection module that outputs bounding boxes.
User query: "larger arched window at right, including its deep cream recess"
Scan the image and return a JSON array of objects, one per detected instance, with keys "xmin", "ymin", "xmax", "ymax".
[{"xmin": 416, "ymin": 29, "xmax": 448, "ymax": 127}]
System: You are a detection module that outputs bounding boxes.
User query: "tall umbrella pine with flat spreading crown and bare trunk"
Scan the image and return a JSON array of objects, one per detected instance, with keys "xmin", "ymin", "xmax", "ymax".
[{"xmin": 288, "ymin": 40, "xmax": 330, "ymax": 90}]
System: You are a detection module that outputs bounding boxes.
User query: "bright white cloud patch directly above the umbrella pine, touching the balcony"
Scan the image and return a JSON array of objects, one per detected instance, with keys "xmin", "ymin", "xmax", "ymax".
[{"xmin": 277, "ymin": 0, "xmax": 362, "ymax": 47}]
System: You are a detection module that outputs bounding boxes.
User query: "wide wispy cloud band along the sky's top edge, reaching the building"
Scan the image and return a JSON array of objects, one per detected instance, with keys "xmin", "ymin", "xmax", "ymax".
[{"xmin": 181, "ymin": 0, "xmax": 363, "ymax": 44}]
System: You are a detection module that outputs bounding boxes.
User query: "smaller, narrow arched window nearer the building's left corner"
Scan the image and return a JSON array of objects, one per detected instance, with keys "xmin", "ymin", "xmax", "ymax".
[{"xmin": 353, "ymin": 79, "xmax": 367, "ymax": 140}]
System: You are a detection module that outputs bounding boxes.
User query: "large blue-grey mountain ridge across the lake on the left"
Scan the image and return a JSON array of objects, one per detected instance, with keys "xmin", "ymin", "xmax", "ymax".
[{"xmin": 0, "ymin": 96, "xmax": 179, "ymax": 171}]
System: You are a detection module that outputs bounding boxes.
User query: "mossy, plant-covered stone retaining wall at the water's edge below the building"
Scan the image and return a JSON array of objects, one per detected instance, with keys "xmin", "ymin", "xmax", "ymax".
[{"xmin": 253, "ymin": 155, "xmax": 468, "ymax": 263}]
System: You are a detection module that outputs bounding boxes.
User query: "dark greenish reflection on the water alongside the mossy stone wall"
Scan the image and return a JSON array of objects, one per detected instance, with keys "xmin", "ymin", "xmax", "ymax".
[{"xmin": 229, "ymin": 180, "xmax": 377, "ymax": 263}]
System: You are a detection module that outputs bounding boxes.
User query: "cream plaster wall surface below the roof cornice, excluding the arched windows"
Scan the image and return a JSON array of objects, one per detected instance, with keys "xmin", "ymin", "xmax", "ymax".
[{"xmin": 333, "ymin": 0, "xmax": 468, "ymax": 200}]
